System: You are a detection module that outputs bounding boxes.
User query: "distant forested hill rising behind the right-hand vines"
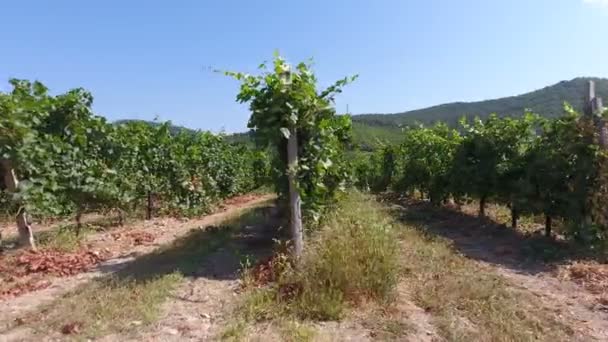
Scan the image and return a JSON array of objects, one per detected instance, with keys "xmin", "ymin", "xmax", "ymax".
[{"xmin": 353, "ymin": 77, "xmax": 608, "ymax": 126}]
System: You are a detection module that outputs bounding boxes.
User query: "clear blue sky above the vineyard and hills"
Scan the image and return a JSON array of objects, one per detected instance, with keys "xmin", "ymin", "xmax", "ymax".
[{"xmin": 0, "ymin": 0, "xmax": 608, "ymax": 132}]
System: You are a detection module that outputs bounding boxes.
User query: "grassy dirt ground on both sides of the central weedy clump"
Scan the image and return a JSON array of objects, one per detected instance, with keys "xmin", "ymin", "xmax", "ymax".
[{"xmin": 0, "ymin": 197, "xmax": 608, "ymax": 341}]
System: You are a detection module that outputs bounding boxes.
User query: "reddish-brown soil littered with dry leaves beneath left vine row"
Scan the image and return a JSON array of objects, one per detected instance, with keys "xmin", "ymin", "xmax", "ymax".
[{"xmin": 0, "ymin": 194, "xmax": 264, "ymax": 301}]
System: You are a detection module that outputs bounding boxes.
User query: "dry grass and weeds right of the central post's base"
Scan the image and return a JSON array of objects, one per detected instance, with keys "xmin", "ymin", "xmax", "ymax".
[{"xmin": 234, "ymin": 194, "xmax": 573, "ymax": 341}]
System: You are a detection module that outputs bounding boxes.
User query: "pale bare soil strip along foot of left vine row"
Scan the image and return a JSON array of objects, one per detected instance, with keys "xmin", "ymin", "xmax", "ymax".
[{"xmin": 0, "ymin": 195, "xmax": 272, "ymax": 341}]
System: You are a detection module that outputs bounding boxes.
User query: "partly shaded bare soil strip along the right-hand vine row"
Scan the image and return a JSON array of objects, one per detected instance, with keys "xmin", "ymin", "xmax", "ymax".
[{"xmin": 402, "ymin": 201, "xmax": 608, "ymax": 341}]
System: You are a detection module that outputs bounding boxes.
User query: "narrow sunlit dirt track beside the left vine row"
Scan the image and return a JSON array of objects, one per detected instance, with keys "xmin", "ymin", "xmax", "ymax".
[{"xmin": 0, "ymin": 195, "xmax": 272, "ymax": 334}]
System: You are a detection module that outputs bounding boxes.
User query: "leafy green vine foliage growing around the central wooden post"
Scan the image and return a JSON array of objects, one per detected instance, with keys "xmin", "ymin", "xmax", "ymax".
[{"xmin": 225, "ymin": 55, "xmax": 356, "ymax": 221}]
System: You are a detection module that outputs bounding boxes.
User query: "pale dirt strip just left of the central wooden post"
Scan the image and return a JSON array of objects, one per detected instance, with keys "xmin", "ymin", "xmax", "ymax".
[{"xmin": 101, "ymin": 207, "xmax": 278, "ymax": 341}]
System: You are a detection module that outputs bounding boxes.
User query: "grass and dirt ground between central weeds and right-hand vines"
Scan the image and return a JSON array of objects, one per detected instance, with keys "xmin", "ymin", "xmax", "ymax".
[{"xmin": 225, "ymin": 194, "xmax": 608, "ymax": 341}]
